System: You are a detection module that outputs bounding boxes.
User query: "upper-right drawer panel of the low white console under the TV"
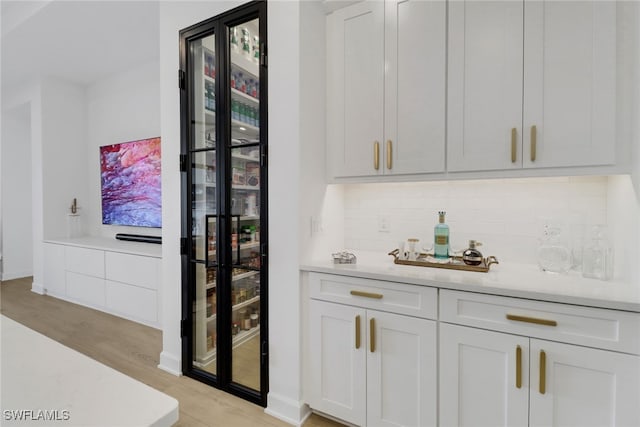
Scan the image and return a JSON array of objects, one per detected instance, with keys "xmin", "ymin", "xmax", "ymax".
[{"xmin": 105, "ymin": 252, "xmax": 160, "ymax": 289}]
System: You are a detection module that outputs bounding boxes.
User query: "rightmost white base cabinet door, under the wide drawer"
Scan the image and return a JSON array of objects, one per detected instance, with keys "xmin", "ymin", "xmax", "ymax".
[{"xmin": 530, "ymin": 339, "xmax": 640, "ymax": 427}]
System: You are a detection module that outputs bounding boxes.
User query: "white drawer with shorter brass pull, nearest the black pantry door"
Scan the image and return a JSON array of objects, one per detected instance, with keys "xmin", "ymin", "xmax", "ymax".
[{"xmin": 309, "ymin": 273, "xmax": 438, "ymax": 319}]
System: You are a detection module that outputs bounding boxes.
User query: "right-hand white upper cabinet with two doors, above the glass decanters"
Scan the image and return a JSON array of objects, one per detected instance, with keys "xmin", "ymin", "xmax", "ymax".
[{"xmin": 447, "ymin": 0, "xmax": 616, "ymax": 171}]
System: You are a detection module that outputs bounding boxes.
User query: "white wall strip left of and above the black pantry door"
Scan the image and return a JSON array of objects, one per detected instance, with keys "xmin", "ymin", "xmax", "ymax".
[{"xmin": 159, "ymin": 1, "xmax": 244, "ymax": 375}]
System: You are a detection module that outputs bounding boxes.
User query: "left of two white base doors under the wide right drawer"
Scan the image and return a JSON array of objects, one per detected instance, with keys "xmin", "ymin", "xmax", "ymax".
[{"xmin": 440, "ymin": 323, "xmax": 529, "ymax": 427}]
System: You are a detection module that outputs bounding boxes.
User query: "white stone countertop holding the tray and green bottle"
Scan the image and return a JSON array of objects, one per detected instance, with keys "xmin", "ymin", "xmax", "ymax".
[{"xmin": 300, "ymin": 251, "xmax": 640, "ymax": 313}]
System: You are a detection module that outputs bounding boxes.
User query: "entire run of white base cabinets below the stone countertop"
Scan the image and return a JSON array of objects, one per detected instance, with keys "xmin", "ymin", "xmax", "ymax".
[{"xmin": 305, "ymin": 272, "xmax": 640, "ymax": 427}]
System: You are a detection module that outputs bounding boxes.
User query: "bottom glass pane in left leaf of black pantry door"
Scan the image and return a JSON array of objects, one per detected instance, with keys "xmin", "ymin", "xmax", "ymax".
[{"xmin": 192, "ymin": 263, "xmax": 217, "ymax": 374}]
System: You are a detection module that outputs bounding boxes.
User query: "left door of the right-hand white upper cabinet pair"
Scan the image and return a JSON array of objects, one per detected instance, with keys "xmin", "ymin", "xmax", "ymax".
[{"xmin": 447, "ymin": 1, "xmax": 523, "ymax": 171}]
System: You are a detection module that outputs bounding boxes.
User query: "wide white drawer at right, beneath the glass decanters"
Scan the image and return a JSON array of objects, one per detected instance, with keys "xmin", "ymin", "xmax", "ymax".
[{"xmin": 440, "ymin": 289, "xmax": 640, "ymax": 354}]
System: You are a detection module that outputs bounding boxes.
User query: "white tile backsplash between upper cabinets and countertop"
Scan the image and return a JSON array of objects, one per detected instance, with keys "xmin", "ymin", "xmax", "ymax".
[{"xmin": 344, "ymin": 176, "xmax": 608, "ymax": 263}]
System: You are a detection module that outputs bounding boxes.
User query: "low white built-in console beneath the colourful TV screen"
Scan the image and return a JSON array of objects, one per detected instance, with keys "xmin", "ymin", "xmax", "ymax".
[{"xmin": 43, "ymin": 238, "xmax": 161, "ymax": 328}]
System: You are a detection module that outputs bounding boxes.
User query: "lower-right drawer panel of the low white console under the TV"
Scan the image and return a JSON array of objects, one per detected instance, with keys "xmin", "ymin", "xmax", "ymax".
[{"xmin": 106, "ymin": 280, "xmax": 158, "ymax": 322}]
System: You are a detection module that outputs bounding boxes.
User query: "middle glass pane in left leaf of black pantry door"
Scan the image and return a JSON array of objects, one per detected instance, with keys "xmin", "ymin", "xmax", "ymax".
[{"xmin": 191, "ymin": 150, "xmax": 216, "ymax": 261}]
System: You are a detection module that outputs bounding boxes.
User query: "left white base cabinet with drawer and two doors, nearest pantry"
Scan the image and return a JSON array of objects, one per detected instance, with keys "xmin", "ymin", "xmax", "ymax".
[{"xmin": 308, "ymin": 274, "xmax": 437, "ymax": 426}]
